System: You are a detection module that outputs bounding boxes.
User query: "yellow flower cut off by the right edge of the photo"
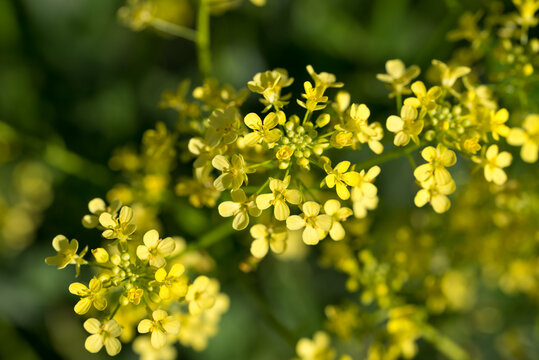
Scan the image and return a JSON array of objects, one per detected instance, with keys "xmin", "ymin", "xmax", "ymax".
[{"xmin": 507, "ymin": 114, "xmax": 539, "ymax": 163}]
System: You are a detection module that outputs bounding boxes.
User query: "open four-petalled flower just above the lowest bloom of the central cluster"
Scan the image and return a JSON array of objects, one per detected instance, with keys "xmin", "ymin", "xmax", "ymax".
[{"xmin": 256, "ymin": 176, "xmax": 301, "ymax": 221}]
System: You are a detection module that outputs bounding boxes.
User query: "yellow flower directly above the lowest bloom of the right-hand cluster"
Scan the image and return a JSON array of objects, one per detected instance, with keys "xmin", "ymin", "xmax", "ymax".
[{"xmin": 414, "ymin": 144, "xmax": 457, "ymax": 184}]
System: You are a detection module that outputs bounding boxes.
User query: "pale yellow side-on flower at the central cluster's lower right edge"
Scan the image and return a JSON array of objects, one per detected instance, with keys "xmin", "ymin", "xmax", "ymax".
[{"xmin": 351, "ymin": 166, "xmax": 380, "ymax": 218}]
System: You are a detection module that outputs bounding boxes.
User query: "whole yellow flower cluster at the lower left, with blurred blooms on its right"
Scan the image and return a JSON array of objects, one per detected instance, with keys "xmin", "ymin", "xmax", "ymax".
[{"xmin": 46, "ymin": 198, "xmax": 228, "ymax": 356}]
